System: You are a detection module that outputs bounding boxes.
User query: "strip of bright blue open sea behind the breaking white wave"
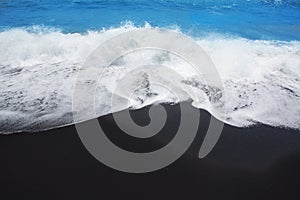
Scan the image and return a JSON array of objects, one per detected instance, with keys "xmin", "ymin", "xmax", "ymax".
[{"xmin": 0, "ymin": 0, "xmax": 300, "ymax": 41}]
